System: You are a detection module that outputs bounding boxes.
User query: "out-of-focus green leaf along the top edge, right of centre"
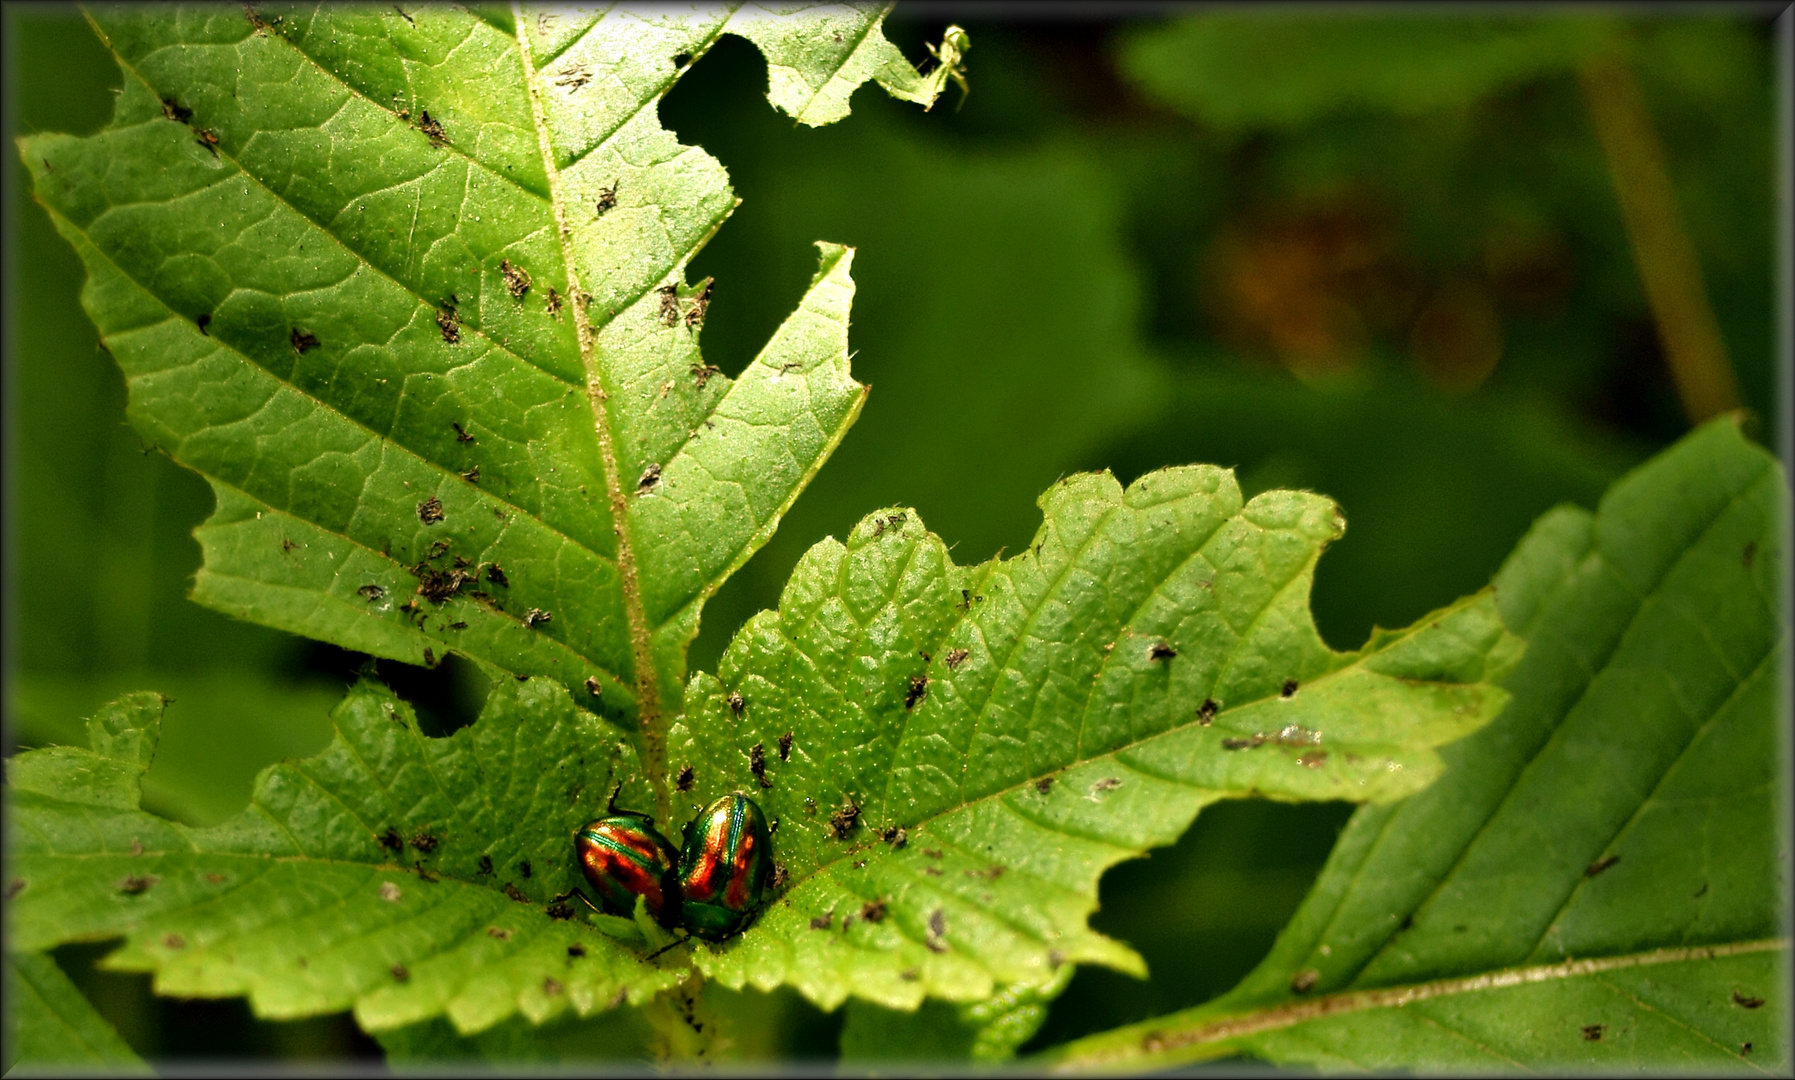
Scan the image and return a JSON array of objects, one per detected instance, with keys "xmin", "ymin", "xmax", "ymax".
[{"xmin": 1120, "ymin": 11, "xmax": 1614, "ymax": 129}]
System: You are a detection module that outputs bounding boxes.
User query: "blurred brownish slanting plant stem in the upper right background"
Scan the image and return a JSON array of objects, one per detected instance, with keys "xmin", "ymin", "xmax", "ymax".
[{"xmin": 1578, "ymin": 54, "xmax": 1739, "ymax": 423}]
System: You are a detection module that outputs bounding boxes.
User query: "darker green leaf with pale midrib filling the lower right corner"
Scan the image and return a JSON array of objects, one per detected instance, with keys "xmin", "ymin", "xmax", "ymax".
[{"xmin": 1052, "ymin": 420, "xmax": 1790, "ymax": 1071}]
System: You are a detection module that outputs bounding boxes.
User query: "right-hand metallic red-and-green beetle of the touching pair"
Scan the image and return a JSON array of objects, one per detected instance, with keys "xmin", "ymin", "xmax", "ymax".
[{"xmin": 679, "ymin": 791, "xmax": 774, "ymax": 942}]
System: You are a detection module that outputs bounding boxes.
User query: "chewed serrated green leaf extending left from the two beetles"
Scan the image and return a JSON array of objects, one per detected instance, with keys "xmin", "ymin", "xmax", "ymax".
[{"xmin": 7, "ymin": 678, "xmax": 700, "ymax": 1033}]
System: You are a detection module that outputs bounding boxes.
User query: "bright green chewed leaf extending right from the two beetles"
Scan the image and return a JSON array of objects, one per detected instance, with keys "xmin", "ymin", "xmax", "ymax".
[{"xmin": 670, "ymin": 466, "xmax": 1520, "ymax": 1008}]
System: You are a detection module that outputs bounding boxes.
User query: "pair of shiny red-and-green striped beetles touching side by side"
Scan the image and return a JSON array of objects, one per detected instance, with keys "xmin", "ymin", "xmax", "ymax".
[{"xmin": 574, "ymin": 791, "xmax": 774, "ymax": 942}]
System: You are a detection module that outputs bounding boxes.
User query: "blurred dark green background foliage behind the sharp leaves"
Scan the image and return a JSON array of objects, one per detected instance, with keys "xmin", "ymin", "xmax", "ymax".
[{"xmin": 5, "ymin": 5, "xmax": 1777, "ymax": 1060}]
